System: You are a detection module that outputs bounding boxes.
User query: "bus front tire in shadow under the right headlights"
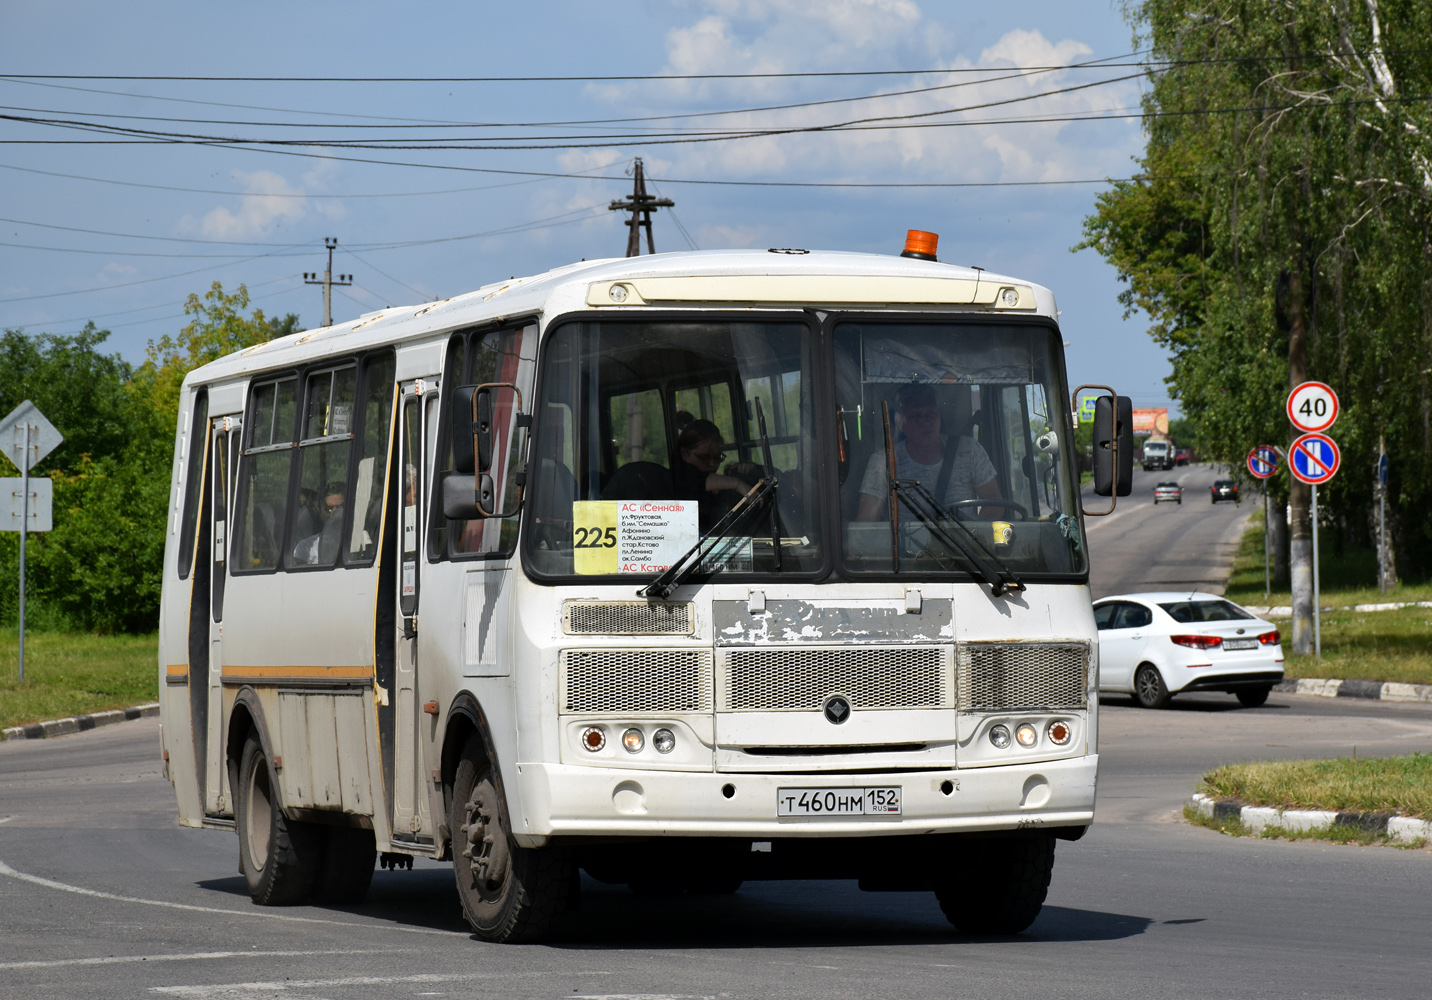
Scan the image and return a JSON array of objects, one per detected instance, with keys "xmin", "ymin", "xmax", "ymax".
[{"xmin": 935, "ymin": 835, "xmax": 1054, "ymax": 934}]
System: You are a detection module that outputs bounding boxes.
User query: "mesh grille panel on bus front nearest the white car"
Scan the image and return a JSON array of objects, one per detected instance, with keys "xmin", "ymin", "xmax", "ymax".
[{"xmin": 959, "ymin": 642, "xmax": 1090, "ymax": 712}]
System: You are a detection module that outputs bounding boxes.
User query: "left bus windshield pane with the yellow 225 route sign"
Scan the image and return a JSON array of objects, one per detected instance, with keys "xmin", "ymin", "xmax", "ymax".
[{"xmin": 526, "ymin": 319, "xmax": 823, "ymax": 582}]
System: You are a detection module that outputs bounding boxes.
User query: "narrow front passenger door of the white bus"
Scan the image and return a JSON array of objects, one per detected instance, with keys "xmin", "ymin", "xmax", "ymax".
[{"xmin": 392, "ymin": 378, "xmax": 437, "ymax": 840}]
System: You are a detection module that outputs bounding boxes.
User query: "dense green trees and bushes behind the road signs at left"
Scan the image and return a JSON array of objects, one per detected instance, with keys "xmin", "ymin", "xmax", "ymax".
[{"xmin": 0, "ymin": 282, "xmax": 298, "ymax": 632}]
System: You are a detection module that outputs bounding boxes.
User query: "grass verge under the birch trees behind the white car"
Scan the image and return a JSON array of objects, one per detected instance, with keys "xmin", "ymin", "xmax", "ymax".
[{"xmin": 1227, "ymin": 514, "xmax": 1432, "ymax": 683}]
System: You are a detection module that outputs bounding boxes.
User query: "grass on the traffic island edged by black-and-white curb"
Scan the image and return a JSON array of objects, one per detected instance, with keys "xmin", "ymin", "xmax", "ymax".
[{"xmin": 1199, "ymin": 754, "xmax": 1432, "ymax": 819}]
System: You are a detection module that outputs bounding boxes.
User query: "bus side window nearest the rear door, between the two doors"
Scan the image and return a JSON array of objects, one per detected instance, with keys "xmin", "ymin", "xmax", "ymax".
[{"xmin": 229, "ymin": 375, "xmax": 298, "ymax": 573}]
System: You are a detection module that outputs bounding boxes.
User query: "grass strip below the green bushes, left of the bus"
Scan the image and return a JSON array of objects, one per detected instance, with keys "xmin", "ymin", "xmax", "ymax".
[{"xmin": 0, "ymin": 628, "xmax": 159, "ymax": 729}]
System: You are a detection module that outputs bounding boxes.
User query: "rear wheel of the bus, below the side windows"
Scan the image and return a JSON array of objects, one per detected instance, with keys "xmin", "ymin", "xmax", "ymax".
[{"xmin": 235, "ymin": 734, "xmax": 324, "ymax": 907}]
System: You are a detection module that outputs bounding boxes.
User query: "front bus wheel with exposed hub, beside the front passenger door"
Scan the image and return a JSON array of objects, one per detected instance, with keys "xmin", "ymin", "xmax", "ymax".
[{"xmin": 448, "ymin": 736, "xmax": 577, "ymax": 943}]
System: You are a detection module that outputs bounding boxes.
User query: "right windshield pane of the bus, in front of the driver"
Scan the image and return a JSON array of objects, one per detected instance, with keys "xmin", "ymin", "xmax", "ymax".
[{"xmin": 835, "ymin": 319, "xmax": 1085, "ymax": 574}]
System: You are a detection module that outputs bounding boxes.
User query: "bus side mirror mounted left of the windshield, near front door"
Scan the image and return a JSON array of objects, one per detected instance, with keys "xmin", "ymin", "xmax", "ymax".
[{"xmin": 442, "ymin": 383, "xmax": 531, "ymax": 520}]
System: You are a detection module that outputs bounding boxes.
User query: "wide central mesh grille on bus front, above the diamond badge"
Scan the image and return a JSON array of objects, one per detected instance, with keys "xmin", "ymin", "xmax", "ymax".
[{"xmin": 717, "ymin": 646, "xmax": 955, "ymax": 712}]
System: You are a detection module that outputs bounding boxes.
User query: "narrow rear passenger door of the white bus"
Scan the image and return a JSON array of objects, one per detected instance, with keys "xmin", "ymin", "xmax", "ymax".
[{"xmin": 199, "ymin": 417, "xmax": 239, "ymax": 815}]
